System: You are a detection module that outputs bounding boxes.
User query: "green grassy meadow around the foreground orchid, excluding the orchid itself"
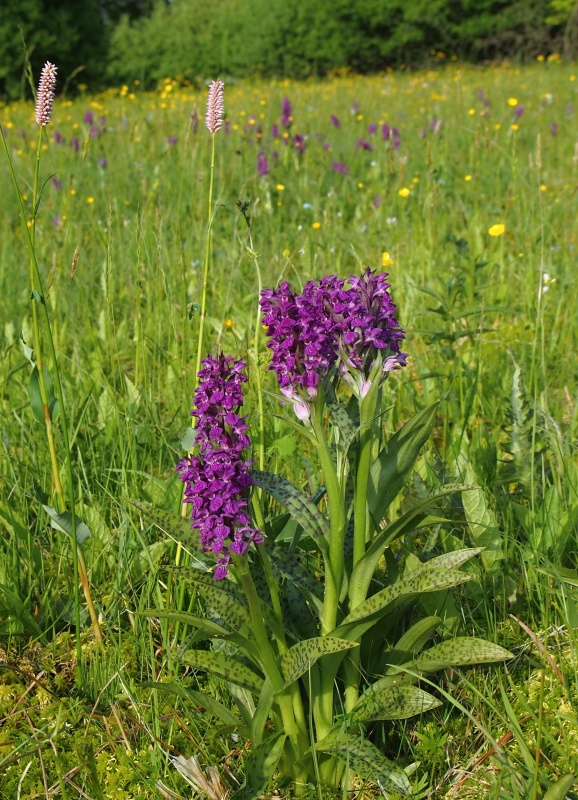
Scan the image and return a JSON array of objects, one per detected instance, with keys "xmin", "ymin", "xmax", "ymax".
[{"xmin": 0, "ymin": 64, "xmax": 578, "ymax": 800}]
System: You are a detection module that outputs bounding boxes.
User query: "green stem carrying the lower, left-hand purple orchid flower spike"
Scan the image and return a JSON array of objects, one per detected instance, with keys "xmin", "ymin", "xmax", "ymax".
[{"xmin": 232, "ymin": 554, "xmax": 309, "ymax": 759}]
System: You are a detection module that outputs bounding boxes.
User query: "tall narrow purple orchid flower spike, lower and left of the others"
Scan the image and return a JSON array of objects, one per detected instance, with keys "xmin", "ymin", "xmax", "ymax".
[{"xmin": 177, "ymin": 353, "xmax": 263, "ymax": 580}]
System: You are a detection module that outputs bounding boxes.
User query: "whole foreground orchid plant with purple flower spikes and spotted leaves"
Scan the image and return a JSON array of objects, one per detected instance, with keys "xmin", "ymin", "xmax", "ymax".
[{"xmin": 142, "ymin": 269, "xmax": 511, "ymax": 800}]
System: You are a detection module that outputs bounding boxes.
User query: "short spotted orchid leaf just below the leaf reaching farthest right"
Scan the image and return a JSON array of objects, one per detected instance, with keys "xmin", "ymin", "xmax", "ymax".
[{"xmin": 352, "ymin": 684, "xmax": 441, "ymax": 722}]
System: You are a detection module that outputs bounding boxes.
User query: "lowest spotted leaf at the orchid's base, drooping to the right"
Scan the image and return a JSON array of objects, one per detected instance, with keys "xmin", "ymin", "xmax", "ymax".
[{"xmin": 316, "ymin": 731, "xmax": 411, "ymax": 795}]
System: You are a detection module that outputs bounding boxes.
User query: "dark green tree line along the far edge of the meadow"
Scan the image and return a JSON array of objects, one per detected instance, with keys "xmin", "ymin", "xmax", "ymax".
[{"xmin": 0, "ymin": 0, "xmax": 578, "ymax": 98}]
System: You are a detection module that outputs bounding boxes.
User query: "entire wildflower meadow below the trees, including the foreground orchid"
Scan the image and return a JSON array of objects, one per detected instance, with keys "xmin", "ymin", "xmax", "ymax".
[{"xmin": 0, "ymin": 55, "xmax": 578, "ymax": 800}]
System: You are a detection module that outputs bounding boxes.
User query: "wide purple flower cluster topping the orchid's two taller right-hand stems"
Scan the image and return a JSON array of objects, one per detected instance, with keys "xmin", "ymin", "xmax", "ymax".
[{"xmin": 260, "ymin": 268, "xmax": 407, "ymax": 410}]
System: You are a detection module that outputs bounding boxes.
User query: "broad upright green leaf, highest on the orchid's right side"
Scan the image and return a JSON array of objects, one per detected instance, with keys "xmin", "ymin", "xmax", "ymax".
[{"xmin": 367, "ymin": 403, "xmax": 438, "ymax": 530}]
